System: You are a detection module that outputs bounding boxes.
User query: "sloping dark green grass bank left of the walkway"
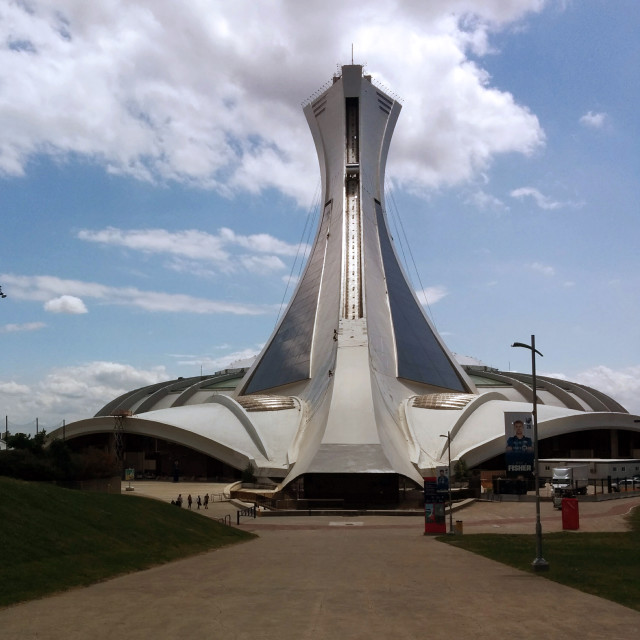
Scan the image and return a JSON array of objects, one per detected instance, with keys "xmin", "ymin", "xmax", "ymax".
[{"xmin": 0, "ymin": 477, "xmax": 255, "ymax": 606}]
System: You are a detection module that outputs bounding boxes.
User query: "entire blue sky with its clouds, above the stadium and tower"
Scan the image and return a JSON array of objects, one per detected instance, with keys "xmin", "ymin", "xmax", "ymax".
[{"xmin": 0, "ymin": 0, "xmax": 640, "ymax": 431}]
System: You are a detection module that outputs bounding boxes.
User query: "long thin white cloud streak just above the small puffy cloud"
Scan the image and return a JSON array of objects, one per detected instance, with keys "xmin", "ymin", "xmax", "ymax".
[{"xmin": 1, "ymin": 273, "xmax": 274, "ymax": 315}]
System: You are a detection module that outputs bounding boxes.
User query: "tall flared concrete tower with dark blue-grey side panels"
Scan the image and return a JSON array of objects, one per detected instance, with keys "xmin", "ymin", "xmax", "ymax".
[{"xmin": 237, "ymin": 64, "xmax": 476, "ymax": 497}]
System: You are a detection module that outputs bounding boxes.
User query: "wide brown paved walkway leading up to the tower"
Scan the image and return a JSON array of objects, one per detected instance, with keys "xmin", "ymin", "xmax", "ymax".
[{"xmin": 0, "ymin": 482, "xmax": 640, "ymax": 640}]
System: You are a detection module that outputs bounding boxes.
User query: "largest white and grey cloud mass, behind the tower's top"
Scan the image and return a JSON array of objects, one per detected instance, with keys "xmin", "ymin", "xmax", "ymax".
[{"xmin": 0, "ymin": 0, "xmax": 544, "ymax": 204}]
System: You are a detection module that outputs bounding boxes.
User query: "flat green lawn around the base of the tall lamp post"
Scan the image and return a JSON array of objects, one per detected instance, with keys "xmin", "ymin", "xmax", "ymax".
[{"xmin": 438, "ymin": 509, "xmax": 640, "ymax": 611}]
